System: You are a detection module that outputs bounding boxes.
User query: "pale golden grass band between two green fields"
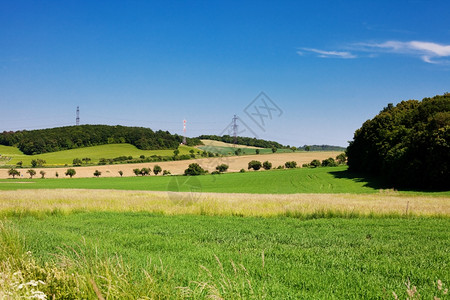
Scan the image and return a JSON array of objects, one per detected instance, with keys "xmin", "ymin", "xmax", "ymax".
[{"xmin": 0, "ymin": 189, "xmax": 450, "ymax": 217}]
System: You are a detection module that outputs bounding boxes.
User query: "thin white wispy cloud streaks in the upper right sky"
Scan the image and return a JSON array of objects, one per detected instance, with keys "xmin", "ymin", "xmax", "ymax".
[{"xmin": 297, "ymin": 41, "xmax": 450, "ymax": 64}]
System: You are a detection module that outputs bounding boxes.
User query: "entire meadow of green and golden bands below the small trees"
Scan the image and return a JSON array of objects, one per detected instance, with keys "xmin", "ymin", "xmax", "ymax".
[{"xmin": 0, "ymin": 167, "xmax": 450, "ymax": 299}]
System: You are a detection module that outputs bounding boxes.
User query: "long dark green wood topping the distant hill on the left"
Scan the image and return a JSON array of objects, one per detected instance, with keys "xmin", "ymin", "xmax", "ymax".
[{"xmin": 0, "ymin": 125, "xmax": 201, "ymax": 155}]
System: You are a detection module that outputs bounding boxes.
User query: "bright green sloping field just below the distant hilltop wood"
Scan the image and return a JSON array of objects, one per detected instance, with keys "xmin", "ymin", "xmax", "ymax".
[{"xmin": 0, "ymin": 144, "xmax": 198, "ymax": 166}]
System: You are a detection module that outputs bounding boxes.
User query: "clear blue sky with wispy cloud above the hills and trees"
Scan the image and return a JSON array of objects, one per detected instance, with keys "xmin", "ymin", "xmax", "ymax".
[{"xmin": 0, "ymin": 0, "xmax": 450, "ymax": 146}]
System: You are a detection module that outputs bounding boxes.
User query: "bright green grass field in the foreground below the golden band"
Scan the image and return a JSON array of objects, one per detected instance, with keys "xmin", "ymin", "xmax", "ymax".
[{"xmin": 0, "ymin": 212, "xmax": 450, "ymax": 299}]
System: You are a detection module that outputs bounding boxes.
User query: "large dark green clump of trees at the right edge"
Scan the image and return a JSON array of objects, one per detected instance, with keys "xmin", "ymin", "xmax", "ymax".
[{"xmin": 347, "ymin": 93, "xmax": 450, "ymax": 189}]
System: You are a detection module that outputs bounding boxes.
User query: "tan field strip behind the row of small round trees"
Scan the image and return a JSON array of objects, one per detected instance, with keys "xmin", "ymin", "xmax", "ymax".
[{"xmin": 0, "ymin": 152, "xmax": 341, "ymax": 179}]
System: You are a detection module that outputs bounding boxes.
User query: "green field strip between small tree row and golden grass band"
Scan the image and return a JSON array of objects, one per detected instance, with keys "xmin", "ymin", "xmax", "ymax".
[{"xmin": 0, "ymin": 167, "xmax": 450, "ymax": 195}]
